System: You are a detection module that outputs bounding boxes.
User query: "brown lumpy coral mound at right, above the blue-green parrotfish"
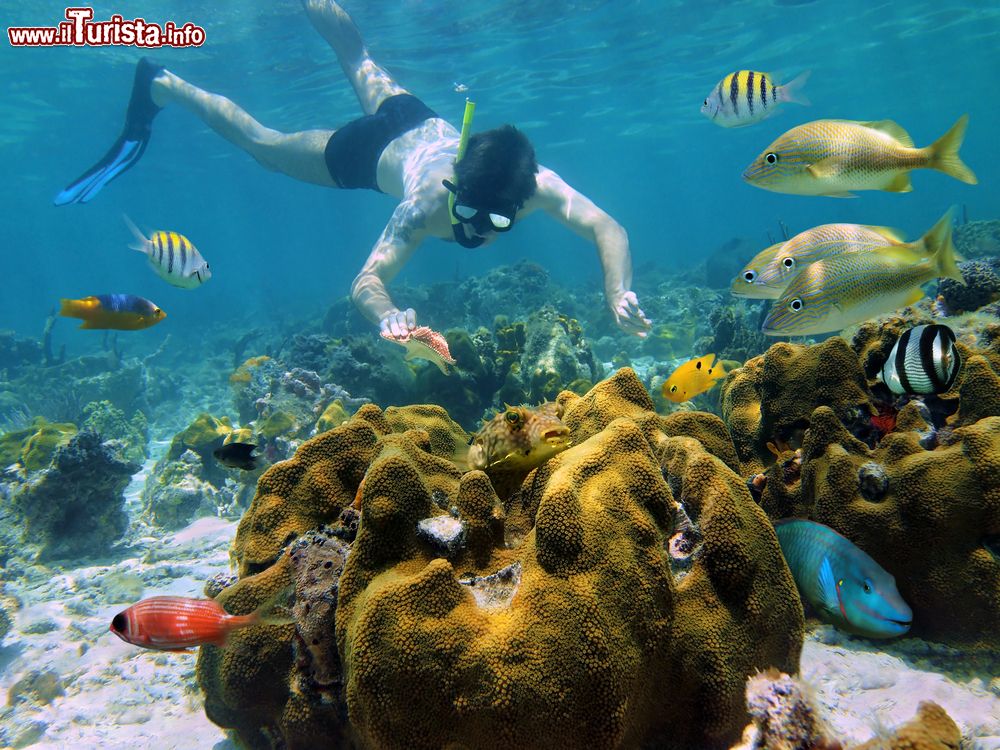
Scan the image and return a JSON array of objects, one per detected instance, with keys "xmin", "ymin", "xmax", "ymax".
[{"xmin": 723, "ymin": 326, "xmax": 1000, "ymax": 648}]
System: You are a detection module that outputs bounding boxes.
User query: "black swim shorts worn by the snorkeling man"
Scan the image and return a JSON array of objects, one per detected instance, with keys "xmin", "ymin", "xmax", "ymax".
[{"xmin": 324, "ymin": 94, "xmax": 437, "ymax": 192}]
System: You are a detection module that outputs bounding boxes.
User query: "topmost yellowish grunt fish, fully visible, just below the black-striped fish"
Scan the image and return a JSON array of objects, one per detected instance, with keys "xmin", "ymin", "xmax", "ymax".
[{"xmin": 743, "ymin": 115, "xmax": 977, "ymax": 198}]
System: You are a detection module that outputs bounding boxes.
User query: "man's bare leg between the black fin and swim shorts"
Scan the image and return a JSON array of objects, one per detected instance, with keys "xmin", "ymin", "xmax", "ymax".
[{"xmin": 150, "ymin": 70, "xmax": 336, "ymax": 187}]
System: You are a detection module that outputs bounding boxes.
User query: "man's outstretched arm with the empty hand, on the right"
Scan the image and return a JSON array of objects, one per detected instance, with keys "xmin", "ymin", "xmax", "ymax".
[{"xmin": 535, "ymin": 167, "xmax": 652, "ymax": 337}]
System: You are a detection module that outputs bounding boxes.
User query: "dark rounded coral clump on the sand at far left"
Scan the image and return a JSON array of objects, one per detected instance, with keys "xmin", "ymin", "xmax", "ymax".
[{"xmin": 9, "ymin": 430, "xmax": 140, "ymax": 560}]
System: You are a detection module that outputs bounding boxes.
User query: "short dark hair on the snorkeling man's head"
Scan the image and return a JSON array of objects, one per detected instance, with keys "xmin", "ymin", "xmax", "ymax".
[{"xmin": 455, "ymin": 125, "xmax": 538, "ymax": 206}]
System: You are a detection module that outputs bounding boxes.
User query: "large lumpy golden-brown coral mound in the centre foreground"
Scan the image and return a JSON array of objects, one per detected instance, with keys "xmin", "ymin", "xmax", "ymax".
[{"xmin": 199, "ymin": 370, "xmax": 803, "ymax": 748}]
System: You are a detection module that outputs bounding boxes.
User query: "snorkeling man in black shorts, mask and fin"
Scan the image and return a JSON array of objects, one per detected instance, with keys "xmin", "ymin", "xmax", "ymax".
[{"xmin": 55, "ymin": 0, "xmax": 650, "ymax": 338}]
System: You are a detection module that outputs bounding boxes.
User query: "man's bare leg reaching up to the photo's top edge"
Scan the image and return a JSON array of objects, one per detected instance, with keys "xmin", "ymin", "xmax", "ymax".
[{"xmin": 302, "ymin": 0, "xmax": 410, "ymax": 115}]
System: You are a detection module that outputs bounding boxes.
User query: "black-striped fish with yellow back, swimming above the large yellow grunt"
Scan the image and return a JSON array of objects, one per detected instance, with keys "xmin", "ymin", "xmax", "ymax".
[{"xmin": 701, "ymin": 70, "xmax": 810, "ymax": 128}]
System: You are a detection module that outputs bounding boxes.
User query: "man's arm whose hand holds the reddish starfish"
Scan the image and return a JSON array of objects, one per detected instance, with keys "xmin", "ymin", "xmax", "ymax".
[{"xmin": 351, "ymin": 201, "xmax": 426, "ymax": 338}]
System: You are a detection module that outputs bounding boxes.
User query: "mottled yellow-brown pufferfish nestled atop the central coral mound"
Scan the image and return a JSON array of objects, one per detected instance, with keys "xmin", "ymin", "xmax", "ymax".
[{"xmin": 468, "ymin": 402, "xmax": 571, "ymax": 471}]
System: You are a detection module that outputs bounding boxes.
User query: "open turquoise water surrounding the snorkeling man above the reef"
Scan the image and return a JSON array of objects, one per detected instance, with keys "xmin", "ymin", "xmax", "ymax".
[{"xmin": 0, "ymin": 1, "xmax": 1000, "ymax": 350}]
